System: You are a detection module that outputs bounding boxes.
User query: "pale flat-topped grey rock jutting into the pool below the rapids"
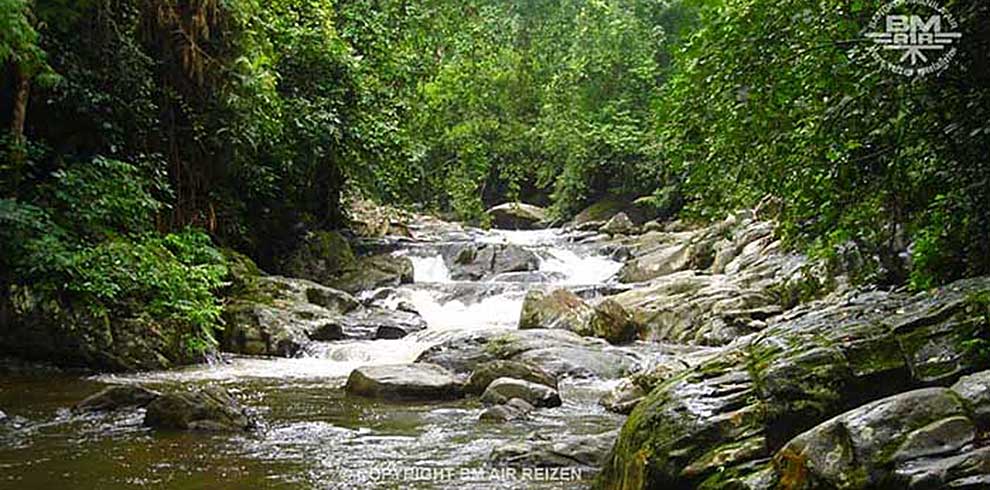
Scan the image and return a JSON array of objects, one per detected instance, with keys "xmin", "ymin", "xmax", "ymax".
[{"xmin": 344, "ymin": 363, "xmax": 463, "ymax": 401}]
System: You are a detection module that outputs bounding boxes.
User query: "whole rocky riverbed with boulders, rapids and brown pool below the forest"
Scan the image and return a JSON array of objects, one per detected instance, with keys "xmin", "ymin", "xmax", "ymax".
[{"xmin": 0, "ymin": 206, "xmax": 990, "ymax": 489}]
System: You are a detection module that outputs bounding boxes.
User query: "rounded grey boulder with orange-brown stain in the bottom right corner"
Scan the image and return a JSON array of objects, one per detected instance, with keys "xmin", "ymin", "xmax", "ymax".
[{"xmin": 774, "ymin": 388, "xmax": 976, "ymax": 489}]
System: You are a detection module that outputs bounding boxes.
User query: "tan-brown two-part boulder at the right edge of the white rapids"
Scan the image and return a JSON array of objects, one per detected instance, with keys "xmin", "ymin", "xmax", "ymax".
[{"xmin": 519, "ymin": 289, "xmax": 637, "ymax": 344}]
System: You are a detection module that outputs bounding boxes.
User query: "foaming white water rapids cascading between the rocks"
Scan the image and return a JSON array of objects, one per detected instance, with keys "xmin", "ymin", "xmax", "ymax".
[{"xmin": 106, "ymin": 230, "xmax": 622, "ymax": 383}]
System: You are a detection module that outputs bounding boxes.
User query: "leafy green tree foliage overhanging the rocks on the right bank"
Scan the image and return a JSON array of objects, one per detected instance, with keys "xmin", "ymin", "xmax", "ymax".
[{"xmin": 655, "ymin": 0, "xmax": 990, "ymax": 288}]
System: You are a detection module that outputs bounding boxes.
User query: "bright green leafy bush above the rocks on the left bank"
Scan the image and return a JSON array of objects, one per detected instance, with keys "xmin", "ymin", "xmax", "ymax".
[{"xmin": 0, "ymin": 153, "xmax": 227, "ymax": 349}]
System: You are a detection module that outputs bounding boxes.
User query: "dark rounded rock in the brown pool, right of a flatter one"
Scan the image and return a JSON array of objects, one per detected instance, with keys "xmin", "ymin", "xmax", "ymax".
[{"xmin": 144, "ymin": 388, "xmax": 256, "ymax": 432}]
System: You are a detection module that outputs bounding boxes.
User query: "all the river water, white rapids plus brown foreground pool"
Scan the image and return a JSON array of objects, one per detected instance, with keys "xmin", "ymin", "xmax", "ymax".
[{"xmin": 0, "ymin": 230, "xmax": 636, "ymax": 490}]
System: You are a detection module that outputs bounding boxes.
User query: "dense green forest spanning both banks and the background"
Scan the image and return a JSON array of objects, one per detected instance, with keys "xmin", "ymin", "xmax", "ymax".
[{"xmin": 0, "ymin": 0, "xmax": 990, "ymax": 360}]
